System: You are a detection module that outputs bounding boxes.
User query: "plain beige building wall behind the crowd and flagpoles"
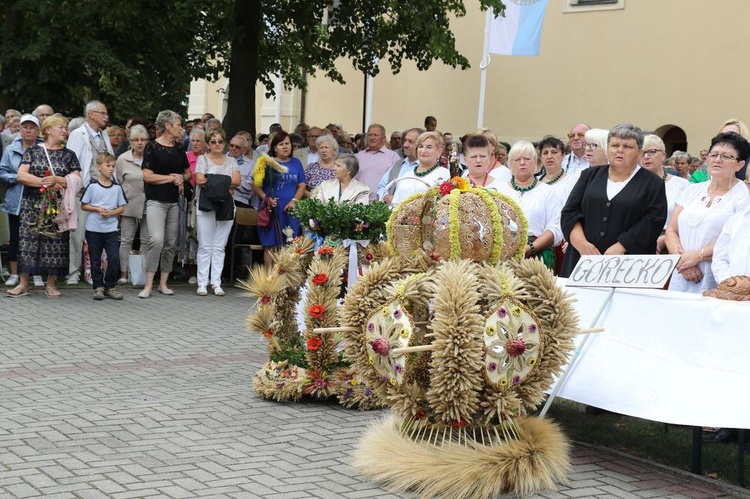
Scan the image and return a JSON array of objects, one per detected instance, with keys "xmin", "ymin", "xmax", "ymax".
[{"xmin": 189, "ymin": 0, "xmax": 750, "ymax": 155}]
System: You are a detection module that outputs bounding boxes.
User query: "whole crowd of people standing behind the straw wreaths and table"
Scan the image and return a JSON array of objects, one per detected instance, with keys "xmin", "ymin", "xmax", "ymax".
[{"xmin": 0, "ymin": 105, "xmax": 750, "ymax": 308}]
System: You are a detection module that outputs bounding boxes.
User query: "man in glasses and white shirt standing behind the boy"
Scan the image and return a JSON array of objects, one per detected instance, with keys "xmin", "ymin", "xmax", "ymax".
[{"xmin": 66, "ymin": 100, "xmax": 114, "ymax": 284}]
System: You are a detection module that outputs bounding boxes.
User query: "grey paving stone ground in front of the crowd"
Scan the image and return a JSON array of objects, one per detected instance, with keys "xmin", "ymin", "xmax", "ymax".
[{"xmin": 0, "ymin": 287, "xmax": 750, "ymax": 499}]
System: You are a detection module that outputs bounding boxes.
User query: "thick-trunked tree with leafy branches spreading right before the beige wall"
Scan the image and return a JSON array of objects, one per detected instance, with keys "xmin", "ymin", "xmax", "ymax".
[{"xmin": 224, "ymin": 0, "xmax": 505, "ymax": 137}]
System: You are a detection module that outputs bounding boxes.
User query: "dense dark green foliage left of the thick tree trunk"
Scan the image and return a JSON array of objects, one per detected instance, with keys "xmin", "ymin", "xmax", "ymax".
[{"xmin": 0, "ymin": 0, "xmax": 232, "ymax": 122}]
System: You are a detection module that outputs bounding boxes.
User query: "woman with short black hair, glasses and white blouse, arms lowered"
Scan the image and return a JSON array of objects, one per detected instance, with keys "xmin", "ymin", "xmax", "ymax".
[{"xmin": 666, "ymin": 132, "xmax": 750, "ymax": 293}]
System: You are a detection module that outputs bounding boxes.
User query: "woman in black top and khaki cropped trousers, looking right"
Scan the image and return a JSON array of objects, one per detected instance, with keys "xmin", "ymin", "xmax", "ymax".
[{"xmin": 138, "ymin": 111, "xmax": 191, "ymax": 298}]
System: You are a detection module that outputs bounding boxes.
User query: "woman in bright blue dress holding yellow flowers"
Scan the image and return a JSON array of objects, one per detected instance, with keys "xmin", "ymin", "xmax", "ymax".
[{"xmin": 253, "ymin": 130, "xmax": 307, "ymax": 268}]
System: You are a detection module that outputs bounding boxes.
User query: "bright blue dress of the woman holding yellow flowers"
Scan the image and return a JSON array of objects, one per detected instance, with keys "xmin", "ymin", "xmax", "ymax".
[{"xmin": 258, "ymin": 158, "xmax": 307, "ymax": 246}]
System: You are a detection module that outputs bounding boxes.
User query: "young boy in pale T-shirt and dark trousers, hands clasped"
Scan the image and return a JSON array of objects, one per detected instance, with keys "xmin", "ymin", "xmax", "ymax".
[{"xmin": 81, "ymin": 152, "xmax": 128, "ymax": 300}]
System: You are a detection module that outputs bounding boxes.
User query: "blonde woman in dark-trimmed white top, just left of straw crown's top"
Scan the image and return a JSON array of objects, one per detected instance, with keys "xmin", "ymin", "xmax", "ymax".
[{"xmin": 391, "ymin": 132, "xmax": 450, "ymax": 205}]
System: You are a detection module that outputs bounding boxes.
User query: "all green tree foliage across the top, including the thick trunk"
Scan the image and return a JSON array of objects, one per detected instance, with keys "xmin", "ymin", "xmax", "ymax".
[{"xmin": 0, "ymin": 0, "xmax": 504, "ymax": 133}]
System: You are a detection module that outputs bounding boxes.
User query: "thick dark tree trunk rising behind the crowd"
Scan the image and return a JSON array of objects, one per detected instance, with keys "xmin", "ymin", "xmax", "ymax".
[{"xmin": 223, "ymin": 0, "xmax": 261, "ymax": 142}]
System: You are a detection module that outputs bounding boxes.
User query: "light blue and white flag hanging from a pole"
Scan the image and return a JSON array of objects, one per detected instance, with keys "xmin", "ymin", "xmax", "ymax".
[{"xmin": 489, "ymin": 0, "xmax": 547, "ymax": 55}]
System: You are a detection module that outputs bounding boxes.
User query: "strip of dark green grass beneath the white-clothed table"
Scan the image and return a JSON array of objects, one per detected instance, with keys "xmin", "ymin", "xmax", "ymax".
[{"xmin": 549, "ymin": 398, "xmax": 748, "ymax": 485}]
